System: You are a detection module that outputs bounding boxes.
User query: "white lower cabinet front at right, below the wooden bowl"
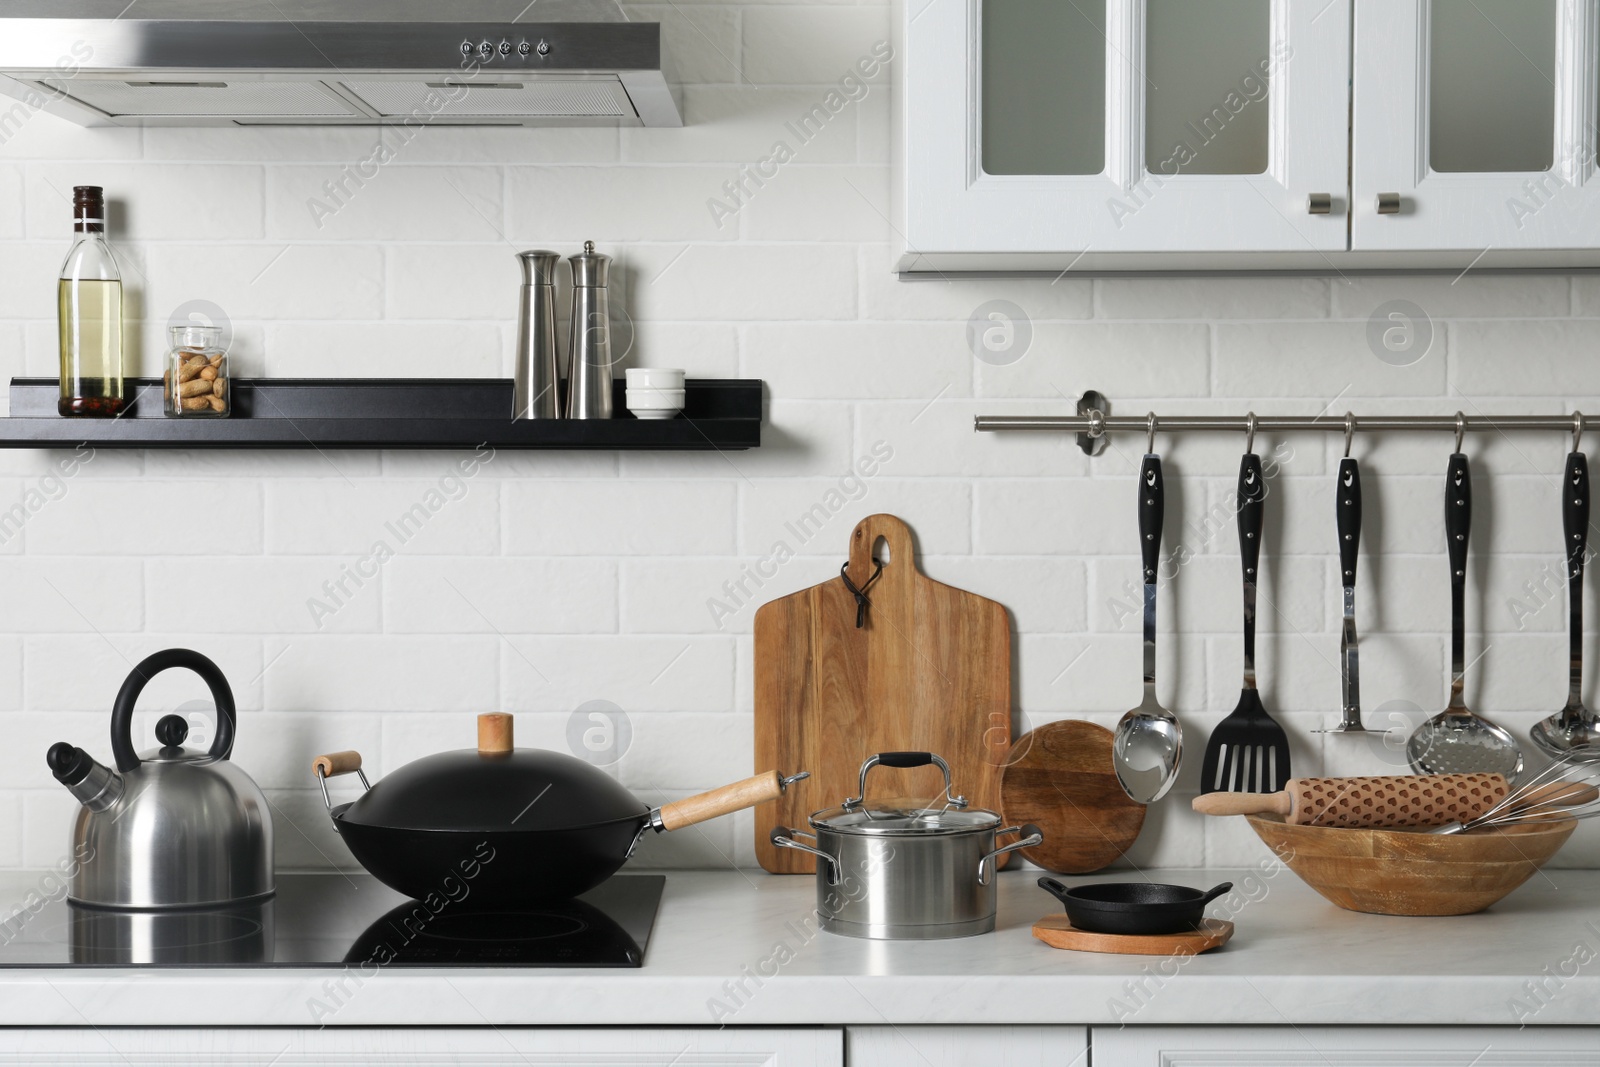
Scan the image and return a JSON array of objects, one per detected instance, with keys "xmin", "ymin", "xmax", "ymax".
[{"xmin": 1094, "ymin": 1027, "xmax": 1600, "ymax": 1067}]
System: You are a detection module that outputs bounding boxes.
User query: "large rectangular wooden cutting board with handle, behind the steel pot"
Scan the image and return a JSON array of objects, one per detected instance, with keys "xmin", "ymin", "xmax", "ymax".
[{"xmin": 755, "ymin": 515, "xmax": 1011, "ymax": 873}]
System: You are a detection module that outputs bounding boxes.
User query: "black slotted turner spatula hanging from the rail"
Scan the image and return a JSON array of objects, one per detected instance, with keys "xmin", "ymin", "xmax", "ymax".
[{"xmin": 1200, "ymin": 451, "xmax": 1290, "ymax": 793}]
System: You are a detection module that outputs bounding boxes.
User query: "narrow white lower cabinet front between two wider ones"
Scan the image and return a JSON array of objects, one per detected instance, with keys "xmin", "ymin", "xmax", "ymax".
[{"xmin": 845, "ymin": 1027, "xmax": 1090, "ymax": 1067}]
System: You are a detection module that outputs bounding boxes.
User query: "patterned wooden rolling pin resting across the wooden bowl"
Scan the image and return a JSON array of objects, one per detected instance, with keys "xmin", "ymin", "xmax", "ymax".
[{"xmin": 1194, "ymin": 774, "xmax": 1595, "ymax": 829}]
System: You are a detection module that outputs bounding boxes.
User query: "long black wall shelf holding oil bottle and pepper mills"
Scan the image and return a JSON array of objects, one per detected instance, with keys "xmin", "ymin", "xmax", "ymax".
[{"xmin": 0, "ymin": 378, "xmax": 762, "ymax": 451}]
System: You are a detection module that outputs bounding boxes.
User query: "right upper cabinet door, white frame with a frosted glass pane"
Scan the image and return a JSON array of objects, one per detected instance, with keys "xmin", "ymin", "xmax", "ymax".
[{"xmin": 1350, "ymin": 0, "xmax": 1600, "ymax": 252}]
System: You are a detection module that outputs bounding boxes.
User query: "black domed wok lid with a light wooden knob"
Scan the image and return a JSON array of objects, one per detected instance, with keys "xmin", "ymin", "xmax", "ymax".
[{"xmin": 339, "ymin": 715, "xmax": 650, "ymax": 832}]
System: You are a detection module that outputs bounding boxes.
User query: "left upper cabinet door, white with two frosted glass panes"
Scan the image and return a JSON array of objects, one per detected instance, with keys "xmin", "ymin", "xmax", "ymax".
[{"xmin": 899, "ymin": 0, "xmax": 1352, "ymax": 270}]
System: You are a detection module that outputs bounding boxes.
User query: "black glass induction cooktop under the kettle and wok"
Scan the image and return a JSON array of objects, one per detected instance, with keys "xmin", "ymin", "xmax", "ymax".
[{"xmin": 0, "ymin": 873, "xmax": 667, "ymax": 968}]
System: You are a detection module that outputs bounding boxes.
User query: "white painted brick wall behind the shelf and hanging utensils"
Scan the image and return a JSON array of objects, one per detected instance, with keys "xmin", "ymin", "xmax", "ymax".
[{"xmin": 0, "ymin": 0, "xmax": 1600, "ymax": 867}]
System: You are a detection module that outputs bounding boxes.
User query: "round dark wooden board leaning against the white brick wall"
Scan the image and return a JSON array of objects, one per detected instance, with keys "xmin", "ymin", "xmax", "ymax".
[{"xmin": 1000, "ymin": 718, "xmax": 1146, "ymax": 875}]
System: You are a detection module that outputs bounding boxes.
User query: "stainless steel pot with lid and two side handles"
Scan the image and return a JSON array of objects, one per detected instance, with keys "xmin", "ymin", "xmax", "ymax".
[{"xmin": 771, "ymin": 752, "xmax": 1045, "ymax": 941}]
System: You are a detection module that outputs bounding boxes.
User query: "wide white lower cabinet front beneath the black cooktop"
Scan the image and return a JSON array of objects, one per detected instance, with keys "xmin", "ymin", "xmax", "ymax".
[{"xmin": 0, "ymin": 1027, "xmax": 845, "ymax": 1067}]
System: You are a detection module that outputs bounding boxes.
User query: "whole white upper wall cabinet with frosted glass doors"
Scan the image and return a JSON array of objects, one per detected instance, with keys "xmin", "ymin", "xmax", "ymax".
[{"xmin": 896, "ymin": 0, "xmax": 1600, "ymax": 272}]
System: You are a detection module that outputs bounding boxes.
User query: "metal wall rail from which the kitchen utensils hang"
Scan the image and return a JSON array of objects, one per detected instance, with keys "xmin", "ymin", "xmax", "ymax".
[{"xmin": 973, "ymin": 403, "xmax": 1586, "ymax": 454}]
